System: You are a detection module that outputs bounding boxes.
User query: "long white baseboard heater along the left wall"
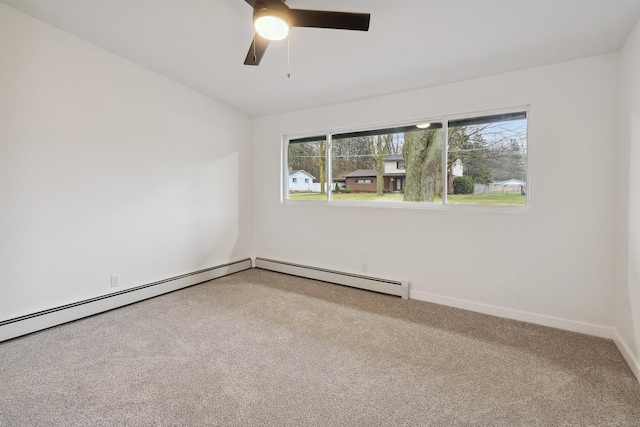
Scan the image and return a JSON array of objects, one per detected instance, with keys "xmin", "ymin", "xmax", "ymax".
[{"xmin": 0, "ymin": 258, "xmax": 252, "ymax": 341}]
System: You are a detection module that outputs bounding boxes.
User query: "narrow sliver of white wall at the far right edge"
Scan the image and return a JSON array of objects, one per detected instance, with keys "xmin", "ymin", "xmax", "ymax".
[{"xmin": 615, "ymin": 18, "xmax": 640, "ymax": 379}]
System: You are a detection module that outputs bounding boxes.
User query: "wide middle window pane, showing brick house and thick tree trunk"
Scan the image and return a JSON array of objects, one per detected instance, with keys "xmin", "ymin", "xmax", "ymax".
[{"xmin": 331, "ymin": 123, "xmax": 443, "ymax": 202}]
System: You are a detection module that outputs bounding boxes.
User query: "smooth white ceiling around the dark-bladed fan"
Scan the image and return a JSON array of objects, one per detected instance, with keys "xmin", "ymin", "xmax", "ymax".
[{"xmin": 0, "ymin": 0, "xmax": 640, "ymax": 116}]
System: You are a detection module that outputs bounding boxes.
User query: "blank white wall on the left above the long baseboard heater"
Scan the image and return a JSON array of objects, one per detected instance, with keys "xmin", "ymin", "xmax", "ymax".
[{"xmin": 0, "ymin": 5, "xmax": 252, "ymax": 321}]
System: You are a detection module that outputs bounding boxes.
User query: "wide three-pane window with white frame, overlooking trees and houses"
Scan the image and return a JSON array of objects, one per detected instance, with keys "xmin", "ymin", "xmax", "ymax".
[{"xmin": 283, "ymin": 109, "xmax": 527, "ymax": 206}]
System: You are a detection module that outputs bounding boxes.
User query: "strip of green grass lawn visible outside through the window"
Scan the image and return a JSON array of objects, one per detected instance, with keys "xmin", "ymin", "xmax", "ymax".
[{"xmin": 289, "ymin": 193, "xmax": 525, "ymax": 206}]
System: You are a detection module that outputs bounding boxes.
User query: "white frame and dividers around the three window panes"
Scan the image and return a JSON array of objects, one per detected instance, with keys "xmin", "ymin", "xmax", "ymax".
[{"xmin": 280, "ymin": 105, "xmax": 531, "ymax": 212}]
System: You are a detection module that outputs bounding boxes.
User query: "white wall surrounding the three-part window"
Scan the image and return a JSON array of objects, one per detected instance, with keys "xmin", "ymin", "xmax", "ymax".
[{"xmin": 253, "ymin": 54, "xmax": 618, "ymax": 336}]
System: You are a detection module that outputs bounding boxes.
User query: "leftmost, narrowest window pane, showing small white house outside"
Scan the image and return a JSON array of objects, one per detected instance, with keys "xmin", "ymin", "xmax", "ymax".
[{"xmin": 287, "ymin": 136, "xmax": 327, "ymax": 200}]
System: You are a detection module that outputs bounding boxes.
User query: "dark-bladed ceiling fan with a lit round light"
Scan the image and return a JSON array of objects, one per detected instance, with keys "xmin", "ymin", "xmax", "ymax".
[{"xmin": 244, "ymin": 0, "xmax": 371, "ymax": 65}]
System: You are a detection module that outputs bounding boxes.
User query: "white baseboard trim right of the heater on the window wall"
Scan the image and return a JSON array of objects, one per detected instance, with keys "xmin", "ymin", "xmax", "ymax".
[{"xmin": 411, "ymin": 290, "xmax": 613, "ymax": 339}]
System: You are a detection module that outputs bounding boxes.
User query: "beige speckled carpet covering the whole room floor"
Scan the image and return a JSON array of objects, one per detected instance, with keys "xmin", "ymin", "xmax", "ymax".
[{"xmin": 0, "ymin": 269, "xmax": 640, "ymax": 426}]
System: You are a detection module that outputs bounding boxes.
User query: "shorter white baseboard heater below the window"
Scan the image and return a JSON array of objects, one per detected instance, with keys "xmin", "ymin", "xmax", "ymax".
[{"xmin": 255, "ymin": 258, "xmax": 409, "ymax": 299}]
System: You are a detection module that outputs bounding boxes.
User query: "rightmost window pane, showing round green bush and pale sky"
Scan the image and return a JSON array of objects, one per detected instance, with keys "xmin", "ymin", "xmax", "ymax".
[{"xmin": 447, "ymin": 112, "xmax": 527, "ymax": 205}]
